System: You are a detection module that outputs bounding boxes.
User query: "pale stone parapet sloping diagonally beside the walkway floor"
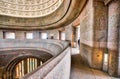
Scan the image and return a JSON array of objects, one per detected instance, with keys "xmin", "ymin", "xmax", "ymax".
[{"xmin": 21, "ymin": 47, "xmax": 71, "ymax": 79}]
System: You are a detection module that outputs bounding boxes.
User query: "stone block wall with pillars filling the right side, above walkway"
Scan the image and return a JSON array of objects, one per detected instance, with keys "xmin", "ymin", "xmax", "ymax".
[{"xmin": 80, "ymin": 0, "xmax": 120, "ymax": 76}]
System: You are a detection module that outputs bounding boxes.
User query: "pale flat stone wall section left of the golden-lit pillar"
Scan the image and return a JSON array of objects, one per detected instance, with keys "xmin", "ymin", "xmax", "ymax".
[{"xmin": 80, "ymin": 0, "xmax": 93, "ymax": 66}]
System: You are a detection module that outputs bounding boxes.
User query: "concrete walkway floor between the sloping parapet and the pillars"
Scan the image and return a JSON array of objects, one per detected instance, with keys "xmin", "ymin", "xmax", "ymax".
[{"xmin": 70, "ymin": 54, "xmax": 120, "ymax": 79}]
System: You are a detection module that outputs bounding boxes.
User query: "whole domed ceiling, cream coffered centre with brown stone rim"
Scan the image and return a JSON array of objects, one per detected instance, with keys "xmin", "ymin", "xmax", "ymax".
[{"xmin": 0, "ymin": 0, "xmax": 87, "ymax": 30}]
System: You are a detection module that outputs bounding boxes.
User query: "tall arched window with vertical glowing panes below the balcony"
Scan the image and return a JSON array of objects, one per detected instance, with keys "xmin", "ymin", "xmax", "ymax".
[{"xmin": 13, "ymin": 58, "xmax": 43, "ymax": 79}]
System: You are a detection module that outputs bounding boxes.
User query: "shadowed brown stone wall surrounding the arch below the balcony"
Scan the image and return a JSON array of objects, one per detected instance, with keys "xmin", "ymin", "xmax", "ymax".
[{"xmin": 0, "ymin": 49, "xmax": 52, "ymax": 67}]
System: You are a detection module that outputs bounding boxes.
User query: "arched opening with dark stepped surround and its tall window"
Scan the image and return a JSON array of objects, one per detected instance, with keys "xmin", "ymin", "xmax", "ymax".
[{"xmin": 3, "ymin": 56, "xmax": 43, "ymax": 79}]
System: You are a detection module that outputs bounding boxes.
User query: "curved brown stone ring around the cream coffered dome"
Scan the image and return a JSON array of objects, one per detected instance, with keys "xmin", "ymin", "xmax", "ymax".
[{"xmin": 0, "ymin": 0, "xmax": 87, "ymax": 30}]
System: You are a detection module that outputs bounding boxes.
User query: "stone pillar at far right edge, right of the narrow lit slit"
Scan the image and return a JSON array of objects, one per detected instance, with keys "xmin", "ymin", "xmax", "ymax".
[{"xmin": 108, "ymin": 0, "xmax": 120, "ymax": 76}]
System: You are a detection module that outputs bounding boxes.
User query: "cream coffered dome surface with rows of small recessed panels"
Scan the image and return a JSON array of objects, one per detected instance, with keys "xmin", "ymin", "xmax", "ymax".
[{"xmin": 0, "ymin": 0, "xmax": 63, "ymax": 18}]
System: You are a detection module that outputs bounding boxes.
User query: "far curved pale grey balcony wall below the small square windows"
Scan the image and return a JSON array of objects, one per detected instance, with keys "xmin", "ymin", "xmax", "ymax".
[{"xmin": 0, "ymin": 39, "xmax": 68, "ymax": 56}]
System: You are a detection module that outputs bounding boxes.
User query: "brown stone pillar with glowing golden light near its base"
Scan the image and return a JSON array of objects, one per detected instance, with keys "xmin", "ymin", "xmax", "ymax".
[{"xmin": 91, "ymin": 0, "xmax": 108, "ymax": 69}]
